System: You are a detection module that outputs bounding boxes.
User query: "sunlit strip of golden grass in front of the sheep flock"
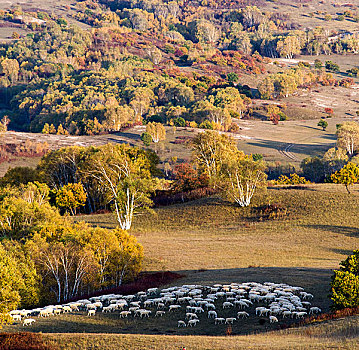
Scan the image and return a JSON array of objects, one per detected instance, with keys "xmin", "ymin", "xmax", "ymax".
[{"xmin": 43, "ymin": 317, "xmax": 359, "ymax": 350}]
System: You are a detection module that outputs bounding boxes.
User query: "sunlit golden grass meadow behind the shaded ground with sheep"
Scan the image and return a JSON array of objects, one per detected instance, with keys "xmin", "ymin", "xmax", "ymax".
[{"xmin": 82, "ymin": 185, "xmax": 359, "ymax": 270}]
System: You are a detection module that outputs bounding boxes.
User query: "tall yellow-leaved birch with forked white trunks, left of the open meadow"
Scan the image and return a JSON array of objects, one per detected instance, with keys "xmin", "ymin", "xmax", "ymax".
[{"xmin": 92, "ymin": 145, "xmax": 154, "ymax": 230}]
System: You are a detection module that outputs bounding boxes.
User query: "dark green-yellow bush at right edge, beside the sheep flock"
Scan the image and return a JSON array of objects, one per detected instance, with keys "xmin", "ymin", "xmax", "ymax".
[{"xmin": 330, "ymin": 250, "xmax": 359, "ymax": 309}]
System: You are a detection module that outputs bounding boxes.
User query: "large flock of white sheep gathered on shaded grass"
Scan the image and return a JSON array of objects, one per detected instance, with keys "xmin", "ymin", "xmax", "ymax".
[{"xmin": 10, "ymin": 282, "xmax": 321, "ymax": 327}]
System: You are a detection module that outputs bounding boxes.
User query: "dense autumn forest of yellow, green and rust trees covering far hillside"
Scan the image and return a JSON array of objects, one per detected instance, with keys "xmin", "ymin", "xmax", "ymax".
[{"xmin": 0, "ymin": 0, "xmax": 359, "ymax": 135}]
